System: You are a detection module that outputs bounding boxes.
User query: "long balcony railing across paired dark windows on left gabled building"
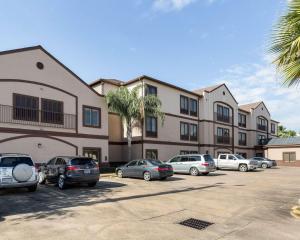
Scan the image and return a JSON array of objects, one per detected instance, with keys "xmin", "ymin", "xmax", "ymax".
[{"xmin": 0, "ymin": 105, "xmax": 76, "ymax": 129}]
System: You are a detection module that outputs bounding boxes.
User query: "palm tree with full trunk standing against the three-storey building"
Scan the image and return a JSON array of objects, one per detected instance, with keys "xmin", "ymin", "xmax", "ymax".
[{"xmin": 106, "ymin": 85, "xmax": 164, "ymax": 161}]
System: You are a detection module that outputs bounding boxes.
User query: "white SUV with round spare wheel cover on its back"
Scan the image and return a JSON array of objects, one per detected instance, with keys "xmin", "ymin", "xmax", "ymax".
[{"xmin": 0, "ymin": 153, "xmax": 38, "ymax": 192}]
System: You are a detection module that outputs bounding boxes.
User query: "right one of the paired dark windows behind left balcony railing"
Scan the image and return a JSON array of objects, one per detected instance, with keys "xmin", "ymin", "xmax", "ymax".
[{"xmin": 41, "ymin": 98, "xmax": 64, "ymax": 124}]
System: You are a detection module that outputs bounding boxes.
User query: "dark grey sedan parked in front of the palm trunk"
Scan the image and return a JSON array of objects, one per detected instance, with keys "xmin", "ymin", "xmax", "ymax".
[{"xmin": 116, "ymin": 159, "xmax": 173, "ymax": 181}]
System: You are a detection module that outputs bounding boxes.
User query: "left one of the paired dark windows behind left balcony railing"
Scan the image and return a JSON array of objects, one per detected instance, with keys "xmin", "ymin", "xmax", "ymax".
[{"xmin": 13, "ymin": 93, "xmax": 39, "ymax": 122}]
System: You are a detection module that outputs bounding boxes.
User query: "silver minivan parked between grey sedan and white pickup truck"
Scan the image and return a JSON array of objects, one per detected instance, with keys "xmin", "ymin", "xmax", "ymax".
[{"xmin": 167, "ymin": 154, "xmax": 216, "ymax": 176}]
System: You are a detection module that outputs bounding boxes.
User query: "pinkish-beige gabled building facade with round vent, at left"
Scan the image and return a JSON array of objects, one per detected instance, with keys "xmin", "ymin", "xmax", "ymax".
[{"xmin": 0, "ymin": 46, "xmax": 109, "ymax": 164}]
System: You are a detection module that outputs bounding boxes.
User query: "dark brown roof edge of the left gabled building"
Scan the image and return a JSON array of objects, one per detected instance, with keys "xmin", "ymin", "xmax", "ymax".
[{"xmin": 0, "ymin": 45, "xmax": 104, "ymax": 97}]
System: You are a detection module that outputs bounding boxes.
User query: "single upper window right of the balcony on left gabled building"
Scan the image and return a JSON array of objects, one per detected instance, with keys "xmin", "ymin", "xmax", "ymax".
[{"xmin": 83, "ymin": 106, "xmax": 101, "ymax": 128}]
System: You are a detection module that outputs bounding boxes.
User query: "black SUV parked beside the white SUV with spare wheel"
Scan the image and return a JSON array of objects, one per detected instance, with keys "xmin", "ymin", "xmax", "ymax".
[{"xmin": 39, "ymin": 156, "xmax": 100, "ymax": 189}]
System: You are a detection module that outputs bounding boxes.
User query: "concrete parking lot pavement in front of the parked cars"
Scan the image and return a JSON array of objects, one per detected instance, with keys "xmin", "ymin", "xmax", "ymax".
[{"xmin": 0, "ymin": 167, "xmax": 300, "ymax": 240}]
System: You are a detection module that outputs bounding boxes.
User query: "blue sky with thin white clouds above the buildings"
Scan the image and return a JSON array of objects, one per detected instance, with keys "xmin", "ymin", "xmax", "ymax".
[{"xmin": 0, "ymin": 0, "xmax": 300, "ymax": 131}]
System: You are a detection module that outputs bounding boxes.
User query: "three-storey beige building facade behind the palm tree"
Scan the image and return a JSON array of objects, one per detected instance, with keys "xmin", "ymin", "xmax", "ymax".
[{"xmin": 90, "ymin": 76, "xmax": 278, "ymax": 162}]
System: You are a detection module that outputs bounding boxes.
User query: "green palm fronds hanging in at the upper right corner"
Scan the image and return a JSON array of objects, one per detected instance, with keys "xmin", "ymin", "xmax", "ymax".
[{"xmin": 270, "ymin": 0, "xmax": 300, "ymax": 87}]
